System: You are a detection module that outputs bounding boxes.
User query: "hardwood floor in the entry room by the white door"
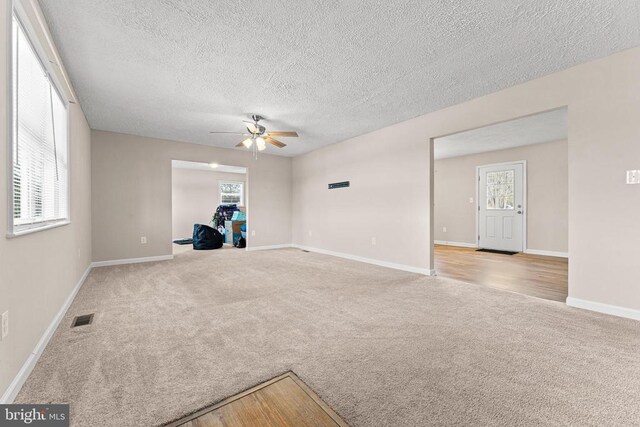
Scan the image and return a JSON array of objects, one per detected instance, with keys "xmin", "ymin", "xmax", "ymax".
[{"xmin": 434, "ymin": 245, "xmax": 569, "ymax": 302}]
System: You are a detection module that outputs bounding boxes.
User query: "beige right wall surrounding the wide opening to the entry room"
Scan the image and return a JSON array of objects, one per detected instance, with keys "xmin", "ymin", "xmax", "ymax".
[{"xmin": 293, "ymin": 48, "xmax": 640, "ymax": 309}]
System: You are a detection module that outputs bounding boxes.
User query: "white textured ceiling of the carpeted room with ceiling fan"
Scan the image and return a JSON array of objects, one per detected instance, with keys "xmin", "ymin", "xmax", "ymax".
[{"xmin": 40, "ymin": 0, "xmax": 640, "ymax": 156}]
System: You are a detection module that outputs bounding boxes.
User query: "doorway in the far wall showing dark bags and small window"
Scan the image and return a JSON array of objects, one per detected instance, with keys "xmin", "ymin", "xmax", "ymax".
[{"xmin": 171, "ymin": 160, "xmax": 248, "ymax": 254}]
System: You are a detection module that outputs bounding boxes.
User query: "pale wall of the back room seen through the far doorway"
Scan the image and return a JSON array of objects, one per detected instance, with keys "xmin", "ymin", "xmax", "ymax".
[{"xmin": 171, "ymin": 168, "xmax": 246, "ymax": 240}]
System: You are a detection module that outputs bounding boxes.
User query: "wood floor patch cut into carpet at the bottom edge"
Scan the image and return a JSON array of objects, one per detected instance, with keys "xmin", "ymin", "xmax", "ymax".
[{"xmin": 168, "ymin": 372, "xmax": 348, "ymax": 427}]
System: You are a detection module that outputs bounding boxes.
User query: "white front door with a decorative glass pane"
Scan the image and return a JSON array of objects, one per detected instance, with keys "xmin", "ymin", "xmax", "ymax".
[{"xmin": 478, "ymin": 162, "xmax": 524, "ymax": 252}]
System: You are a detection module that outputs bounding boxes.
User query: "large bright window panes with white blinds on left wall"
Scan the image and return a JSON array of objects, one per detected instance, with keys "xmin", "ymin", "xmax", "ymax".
[{"xmin": 10, "ymin": 15, "xmax": 69, "ymax": 234}]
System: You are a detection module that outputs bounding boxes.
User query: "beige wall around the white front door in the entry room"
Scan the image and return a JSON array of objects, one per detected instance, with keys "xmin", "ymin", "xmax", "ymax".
[{"xmin": 433, "ymin": 140, "xmax": 569, "ymax": 253}]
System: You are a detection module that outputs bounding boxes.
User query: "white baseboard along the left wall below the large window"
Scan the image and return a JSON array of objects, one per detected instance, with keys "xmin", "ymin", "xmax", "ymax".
[{"xmin": 0, "ymin": 265, "xmax": 92, "ymax": 404}]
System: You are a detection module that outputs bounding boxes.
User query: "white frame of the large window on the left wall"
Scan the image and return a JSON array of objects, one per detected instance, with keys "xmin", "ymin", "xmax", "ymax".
[{"xmin": 6, "ymin": 5, "xmax": 71, "ymax": 238}]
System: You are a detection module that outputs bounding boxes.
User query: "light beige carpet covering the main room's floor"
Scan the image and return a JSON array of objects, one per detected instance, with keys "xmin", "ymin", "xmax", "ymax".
[{"xmin": 17, "ymin": 248, "xmax": 640, "ymax": 426}]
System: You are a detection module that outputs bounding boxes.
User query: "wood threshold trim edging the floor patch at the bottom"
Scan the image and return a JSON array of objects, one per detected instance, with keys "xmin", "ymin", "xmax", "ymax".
[{"xmin": 164, "ymin": 371, "xmax": 349, "ymax": 427}]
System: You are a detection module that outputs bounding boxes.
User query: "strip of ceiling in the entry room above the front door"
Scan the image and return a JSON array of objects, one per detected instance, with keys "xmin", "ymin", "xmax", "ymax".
[{"xmin": 433, "ymin": 108, "xmax": 568, "ymax": 160}]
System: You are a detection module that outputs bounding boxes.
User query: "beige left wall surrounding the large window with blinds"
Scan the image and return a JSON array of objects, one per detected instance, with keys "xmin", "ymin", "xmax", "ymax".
[{"xmin": 0, "ymin": 4, "xmax": 91, "ymax": 395}]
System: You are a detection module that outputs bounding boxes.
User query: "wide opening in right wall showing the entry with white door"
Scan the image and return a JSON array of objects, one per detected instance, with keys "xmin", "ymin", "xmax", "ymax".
[{"xmin": 433, "ymin": 108, "xmax": 569, "ymax": 302}]
